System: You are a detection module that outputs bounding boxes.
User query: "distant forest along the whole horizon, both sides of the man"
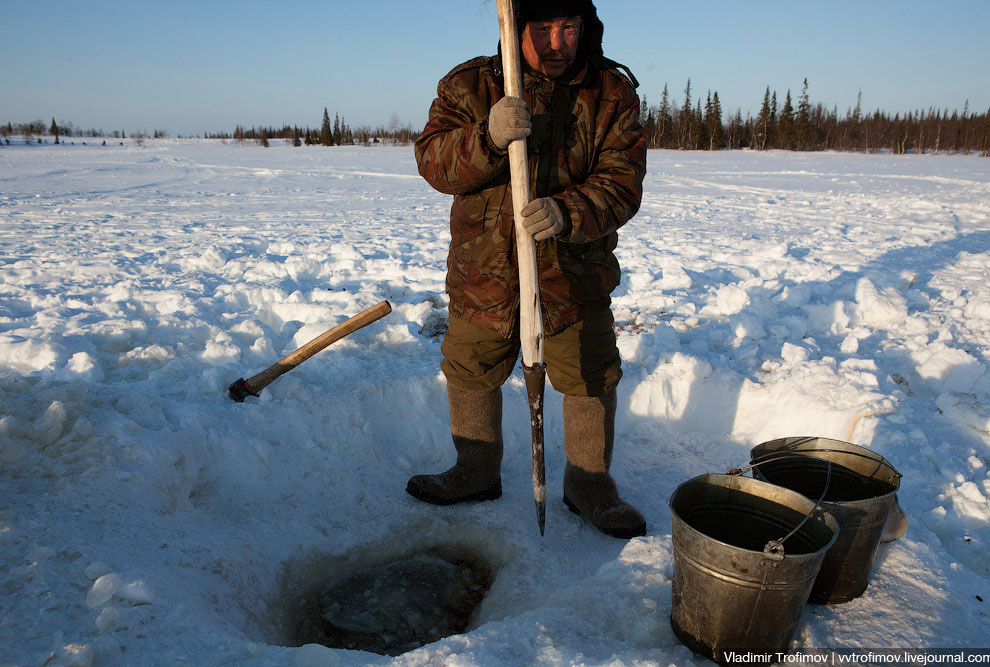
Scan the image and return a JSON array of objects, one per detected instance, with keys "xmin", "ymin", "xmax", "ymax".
[{"xmin": 0, "ymin": 79, "xmax": 990, "ymax": 157}]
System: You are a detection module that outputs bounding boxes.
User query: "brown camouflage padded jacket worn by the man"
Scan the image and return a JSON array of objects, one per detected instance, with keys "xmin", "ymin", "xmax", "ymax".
[{"xmin": 415, "ymin": 56, "xmax": 646, "ymax": 338}]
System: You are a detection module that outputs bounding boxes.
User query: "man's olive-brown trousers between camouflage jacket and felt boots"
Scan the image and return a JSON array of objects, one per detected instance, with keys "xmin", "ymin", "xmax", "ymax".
[{"xmin": 440, "ymin": 308, "xmax": 622, "ymax": 396}]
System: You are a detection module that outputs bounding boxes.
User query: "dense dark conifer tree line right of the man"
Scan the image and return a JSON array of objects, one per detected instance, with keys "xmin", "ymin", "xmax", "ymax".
[{"xmin": 641, "ymin": 79, "xmax": 990, "ymax": 157}]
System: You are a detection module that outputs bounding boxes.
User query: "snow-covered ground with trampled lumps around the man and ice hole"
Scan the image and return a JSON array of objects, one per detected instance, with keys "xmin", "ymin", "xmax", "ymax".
[{"xmin": 0, "ymin": 140, "xmax": 990, "ymax": 666}]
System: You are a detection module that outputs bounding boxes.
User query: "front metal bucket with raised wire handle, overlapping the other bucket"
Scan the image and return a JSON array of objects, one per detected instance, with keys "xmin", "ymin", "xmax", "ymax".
[{"xmin": 670, "ymin": 475, "xmax": 838, "ymax": 664}]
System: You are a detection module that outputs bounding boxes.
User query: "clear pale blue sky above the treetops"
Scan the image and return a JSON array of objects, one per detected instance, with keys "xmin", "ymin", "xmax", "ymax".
[{"xmin": 0, "ymin": 0, "xmax": 990, "ymax": 136}]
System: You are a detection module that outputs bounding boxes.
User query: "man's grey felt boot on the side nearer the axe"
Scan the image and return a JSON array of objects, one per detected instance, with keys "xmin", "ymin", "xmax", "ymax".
[{"xmin": 406, "ymin": 384, "xmax": 502, "ymax": 505}]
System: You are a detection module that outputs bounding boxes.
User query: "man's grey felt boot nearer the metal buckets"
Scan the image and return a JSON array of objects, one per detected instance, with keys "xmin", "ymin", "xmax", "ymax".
[{"xmin": 564, "ymin": 391, "xmax": 646, "ymax": 539}]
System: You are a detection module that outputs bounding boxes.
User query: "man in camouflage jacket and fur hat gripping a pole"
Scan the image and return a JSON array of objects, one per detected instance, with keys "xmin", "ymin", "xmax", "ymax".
[{"xmin": 407, "ymin": 0, "xmax": 646, "ymax": 538}]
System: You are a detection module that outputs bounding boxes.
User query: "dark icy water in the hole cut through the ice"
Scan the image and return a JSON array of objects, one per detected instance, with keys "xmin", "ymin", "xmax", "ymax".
[{"xmin": 289, "ymin": 548, "xmax": 493, "ymax": 656}]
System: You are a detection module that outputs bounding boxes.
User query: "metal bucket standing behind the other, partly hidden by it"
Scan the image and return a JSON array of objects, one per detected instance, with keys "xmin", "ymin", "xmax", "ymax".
[{"xmin": 750, "ymin": 438, "xmax": 901, "ymax": 604}]
